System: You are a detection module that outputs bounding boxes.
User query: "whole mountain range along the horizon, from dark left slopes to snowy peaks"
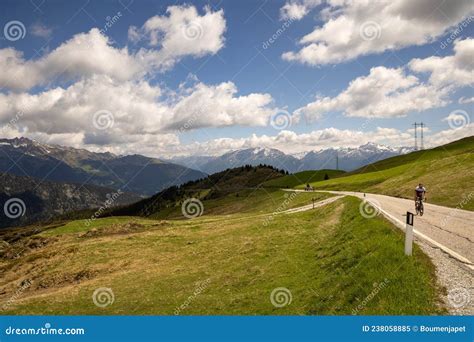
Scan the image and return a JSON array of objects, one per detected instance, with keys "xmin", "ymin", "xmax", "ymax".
[{"xmin": 0, "ymin": 138, "xmax": 410, "ymax": 227}]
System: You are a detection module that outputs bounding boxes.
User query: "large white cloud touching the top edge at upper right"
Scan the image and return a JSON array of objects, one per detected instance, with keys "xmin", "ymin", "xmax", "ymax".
[{"xmin": 282, "ymin": 0, "xmax": 473, "ymax": 65}]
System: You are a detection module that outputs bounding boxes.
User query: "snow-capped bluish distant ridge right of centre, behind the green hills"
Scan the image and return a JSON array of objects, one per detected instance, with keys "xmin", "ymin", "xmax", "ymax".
[{"xmin": 169, "ymin": 143, "xmax": 413, "ymax": 174}]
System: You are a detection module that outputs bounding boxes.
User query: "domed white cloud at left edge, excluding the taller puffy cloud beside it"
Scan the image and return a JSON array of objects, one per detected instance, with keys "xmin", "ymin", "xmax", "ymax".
[{"xmin": 0, "ymin": 28, "xmax": 143, "ymax": 90}]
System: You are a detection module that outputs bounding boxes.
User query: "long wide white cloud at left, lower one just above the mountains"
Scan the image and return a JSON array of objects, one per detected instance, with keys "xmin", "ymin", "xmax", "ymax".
[{"xmin": 0, "ymin": 75, "xmax": 275, "ymax": 145}]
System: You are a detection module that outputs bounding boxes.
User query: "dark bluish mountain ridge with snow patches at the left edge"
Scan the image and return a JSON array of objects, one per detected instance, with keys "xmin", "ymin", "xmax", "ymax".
[{"xmin": 0, "ymin": 137, "xmax": 206, "ymax": 196}]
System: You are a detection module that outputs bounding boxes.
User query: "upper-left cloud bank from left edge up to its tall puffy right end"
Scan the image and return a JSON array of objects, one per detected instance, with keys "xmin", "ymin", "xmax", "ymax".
[{"xmin": 0, "ymin": 6, "xmax": 226, "ymax": 90}]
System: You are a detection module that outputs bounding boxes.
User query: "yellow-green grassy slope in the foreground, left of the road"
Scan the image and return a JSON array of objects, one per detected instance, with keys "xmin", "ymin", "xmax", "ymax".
[{"xmin": 0, "ymin": 195, "xmax": 444, "ymax": 315}]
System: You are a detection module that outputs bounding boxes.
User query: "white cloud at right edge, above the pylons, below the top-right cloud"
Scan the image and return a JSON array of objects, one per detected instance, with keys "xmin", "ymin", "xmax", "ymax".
[{"xmin": 295, "ymin": 39, "xmax": 474, "ymax": 120}]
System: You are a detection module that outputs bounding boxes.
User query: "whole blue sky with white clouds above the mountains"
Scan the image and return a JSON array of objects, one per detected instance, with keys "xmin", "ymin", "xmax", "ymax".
[{"xmin": 0, "ymin": 0, "xmax": 474, "ymax": 156}]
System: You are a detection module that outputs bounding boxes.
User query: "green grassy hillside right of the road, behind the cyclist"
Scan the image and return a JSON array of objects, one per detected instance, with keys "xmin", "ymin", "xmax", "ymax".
[{"xmin": 297, "ymin": 137, "xmax": 474, "ymax": 210}]
